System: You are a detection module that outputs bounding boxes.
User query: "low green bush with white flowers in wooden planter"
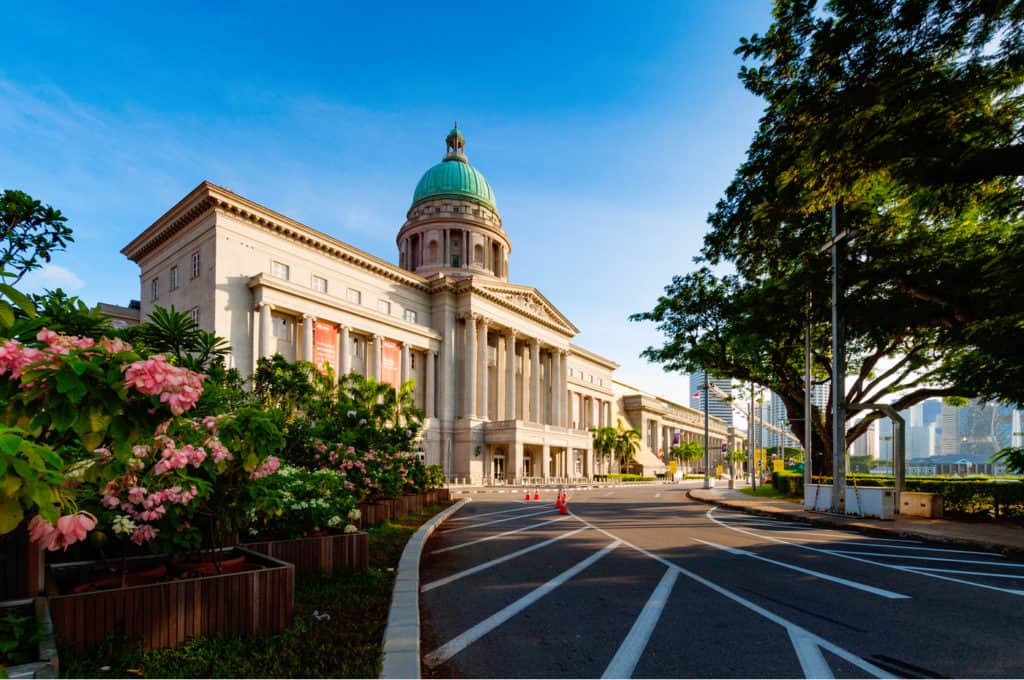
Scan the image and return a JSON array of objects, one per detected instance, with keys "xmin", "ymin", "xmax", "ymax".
[{"xmin": 249, "ymin": 465, "xmax": 358, "ymax": 538}]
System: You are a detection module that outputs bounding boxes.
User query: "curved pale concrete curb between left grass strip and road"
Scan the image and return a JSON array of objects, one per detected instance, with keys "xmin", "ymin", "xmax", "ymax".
[{"xmin": 380, "ymin": 498, "xmax": 472, "ymax": 680}]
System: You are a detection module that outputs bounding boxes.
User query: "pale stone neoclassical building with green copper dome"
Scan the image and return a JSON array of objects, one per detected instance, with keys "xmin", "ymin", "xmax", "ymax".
[{"xmin": 122, "ymin": 128, "xmax": 739, "ymax": 482}]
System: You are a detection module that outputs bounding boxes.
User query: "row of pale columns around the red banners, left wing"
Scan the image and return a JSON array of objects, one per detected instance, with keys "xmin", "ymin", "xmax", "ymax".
[{"xmin": 257, "ymin": 302, "xmax": 437, "ymax": 418}]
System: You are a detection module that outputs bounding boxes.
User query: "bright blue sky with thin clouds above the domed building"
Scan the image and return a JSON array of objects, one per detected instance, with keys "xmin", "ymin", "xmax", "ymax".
[{"xmin": 0, "ymin": 0, "xmax": 770, "ymax": 400}]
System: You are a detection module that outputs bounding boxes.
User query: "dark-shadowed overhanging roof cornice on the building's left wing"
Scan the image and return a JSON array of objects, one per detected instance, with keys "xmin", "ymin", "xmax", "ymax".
[{"xmin": 121, "ymin": 180, "xmax": 428, "ymax": 291}]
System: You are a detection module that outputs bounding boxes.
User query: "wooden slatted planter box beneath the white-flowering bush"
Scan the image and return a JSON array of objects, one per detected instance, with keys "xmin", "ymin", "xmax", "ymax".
[{"xmin": 246, "ymin": 532, "xmax": 370, "ymax": 576}]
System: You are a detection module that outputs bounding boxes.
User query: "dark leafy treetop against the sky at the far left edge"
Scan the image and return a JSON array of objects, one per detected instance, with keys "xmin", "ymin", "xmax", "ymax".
[{"xmin": 0, "ymin": 189, "xmax": 74, "ymax": 284}]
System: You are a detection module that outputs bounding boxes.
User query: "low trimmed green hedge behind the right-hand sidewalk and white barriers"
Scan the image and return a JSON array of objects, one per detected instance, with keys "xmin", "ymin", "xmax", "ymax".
[{"xmin": 772, "ymin": 471, "xmax": 1024, "ymax": 519}]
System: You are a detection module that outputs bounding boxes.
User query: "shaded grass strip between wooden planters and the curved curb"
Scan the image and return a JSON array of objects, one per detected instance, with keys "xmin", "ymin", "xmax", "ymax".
[{"xmin": 60, "ymin": 505, "xmax": 446, "ymax": 678}]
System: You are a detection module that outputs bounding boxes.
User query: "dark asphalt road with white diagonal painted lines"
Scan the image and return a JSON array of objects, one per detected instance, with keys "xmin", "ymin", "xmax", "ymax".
[{"xmin": 420, "ymin": 485, "xmax": 1024, "ymax": 678}]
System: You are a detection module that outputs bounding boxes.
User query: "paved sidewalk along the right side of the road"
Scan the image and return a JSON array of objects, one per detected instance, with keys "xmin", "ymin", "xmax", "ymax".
[{"xmin": 687, "ymin": 488, "xmax": 1024, "ymax": 557}]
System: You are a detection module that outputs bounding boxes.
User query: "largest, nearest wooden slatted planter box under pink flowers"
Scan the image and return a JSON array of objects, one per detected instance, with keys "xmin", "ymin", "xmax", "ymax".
[{"xmin": 47, "ymin": 548, "xmax": 295, "ymax": 653}]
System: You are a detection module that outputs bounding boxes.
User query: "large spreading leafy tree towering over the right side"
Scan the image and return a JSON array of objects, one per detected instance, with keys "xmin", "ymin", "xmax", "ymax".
[{"xmin": 634, "ymin": 0, "xmax": 1024, "ymax": 470}]
